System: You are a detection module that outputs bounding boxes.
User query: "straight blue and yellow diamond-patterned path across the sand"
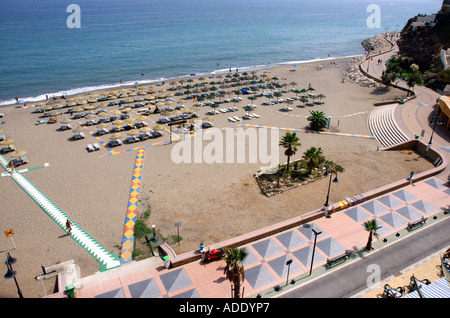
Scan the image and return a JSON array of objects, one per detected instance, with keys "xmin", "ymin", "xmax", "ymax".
[{"xmin": 120, "ymin": 148, "xmax": 145, "ymax": 264}]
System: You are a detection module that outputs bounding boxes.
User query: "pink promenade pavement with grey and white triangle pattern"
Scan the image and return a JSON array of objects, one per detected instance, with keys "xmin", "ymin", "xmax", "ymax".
[{"xmin": 77, "ymin": 177, "xmax": 450, "ymax": 298}]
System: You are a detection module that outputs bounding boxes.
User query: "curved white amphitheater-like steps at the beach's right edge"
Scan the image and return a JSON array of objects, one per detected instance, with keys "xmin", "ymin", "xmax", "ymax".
[{"xmin": 368, "ymin": 103, "xmax": 409, "ymax": 148}]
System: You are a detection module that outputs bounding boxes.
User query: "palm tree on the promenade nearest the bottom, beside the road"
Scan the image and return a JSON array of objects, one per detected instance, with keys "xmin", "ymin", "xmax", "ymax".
[{"xmin": 223, "ymin": 247, "xmax": 248, "ymax": 298}]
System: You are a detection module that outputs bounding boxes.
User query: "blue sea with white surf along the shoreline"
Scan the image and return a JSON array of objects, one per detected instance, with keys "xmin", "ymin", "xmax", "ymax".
[{"xmin": 0, "ymin": 0, "xmax": 442, "ymax": 106}]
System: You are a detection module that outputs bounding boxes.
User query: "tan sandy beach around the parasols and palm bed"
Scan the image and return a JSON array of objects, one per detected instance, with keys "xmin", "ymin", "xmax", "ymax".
[{"xmin": 0, "ymin": 52, "xmax": 432, "ymax": 297}]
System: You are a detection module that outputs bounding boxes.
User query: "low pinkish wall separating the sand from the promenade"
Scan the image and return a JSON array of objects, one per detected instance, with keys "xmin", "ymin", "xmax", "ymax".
[{"xmin": 160, "ymin": 139, "xmax": 448, "ymax": 267}]
